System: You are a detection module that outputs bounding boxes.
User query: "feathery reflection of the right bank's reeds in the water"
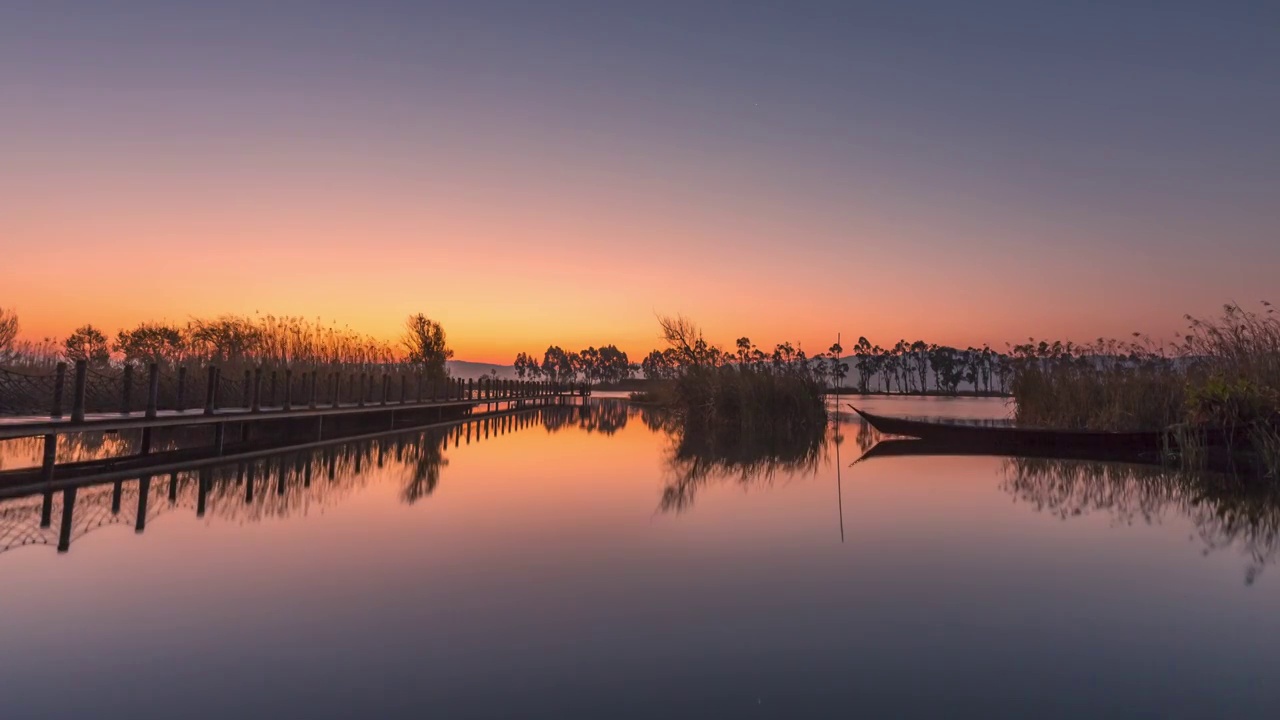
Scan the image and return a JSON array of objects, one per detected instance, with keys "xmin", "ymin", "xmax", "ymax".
[{"xmin": 1001, "ymin": 457, "xmax": 1280, "ymax": 584}]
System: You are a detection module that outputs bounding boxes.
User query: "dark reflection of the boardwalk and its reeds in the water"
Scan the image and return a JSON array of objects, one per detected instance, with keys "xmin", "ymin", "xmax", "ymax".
[{"xmin": 0, "ymin": 401, "xmax": 628, "ymax": 553}]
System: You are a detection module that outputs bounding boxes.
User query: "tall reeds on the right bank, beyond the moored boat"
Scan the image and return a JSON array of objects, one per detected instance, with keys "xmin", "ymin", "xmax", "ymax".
[{"xmin": 1011, "ymin": 302, "xmax": 1280, "ymax": 477}]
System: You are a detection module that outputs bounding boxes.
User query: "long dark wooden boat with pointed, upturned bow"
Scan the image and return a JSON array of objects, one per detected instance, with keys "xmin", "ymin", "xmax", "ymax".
[{"xmin": 850, "ymin": 405, "xmax": 1166, "ymax": 456}]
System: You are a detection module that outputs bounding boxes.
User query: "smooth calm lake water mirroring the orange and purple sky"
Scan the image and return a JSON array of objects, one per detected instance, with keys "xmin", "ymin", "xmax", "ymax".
[{"xmin": 0, "ymin": 398, "xmax": 1280, "ymax": 719}]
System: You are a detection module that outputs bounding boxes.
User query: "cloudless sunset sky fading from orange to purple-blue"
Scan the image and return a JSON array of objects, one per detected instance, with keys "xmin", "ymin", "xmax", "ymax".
[{"xmin": 0, "ymin": 0, "xmax": 1280, "ymax": 363}]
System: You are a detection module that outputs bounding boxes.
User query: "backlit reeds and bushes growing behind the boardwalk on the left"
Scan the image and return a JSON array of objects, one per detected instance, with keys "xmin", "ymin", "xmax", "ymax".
[{"xmin": 0, "ymin": 307, "xmax": 453, "ymax": 379}]
